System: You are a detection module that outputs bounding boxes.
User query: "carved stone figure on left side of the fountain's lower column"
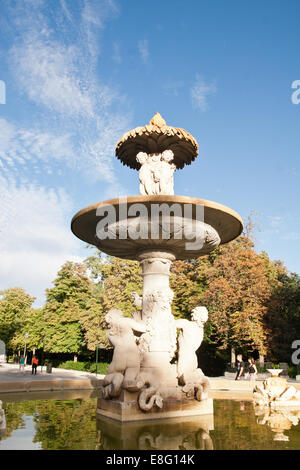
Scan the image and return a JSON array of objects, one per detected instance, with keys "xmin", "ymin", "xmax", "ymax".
[{"xmin": 102, "ymin": 309, "xmax": 145, "ymax": 398}]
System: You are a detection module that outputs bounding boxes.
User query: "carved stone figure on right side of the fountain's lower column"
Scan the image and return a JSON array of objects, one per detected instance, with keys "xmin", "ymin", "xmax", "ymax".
[{"xmin": 176, "ymin": 307, "xmax": 209, "ymax": 401}]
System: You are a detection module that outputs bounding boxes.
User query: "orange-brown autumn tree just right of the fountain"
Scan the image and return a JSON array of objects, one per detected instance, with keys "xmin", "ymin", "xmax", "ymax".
[{"xmin": 203, "ymin": 237, "xmax": 272, "ymax": 354}]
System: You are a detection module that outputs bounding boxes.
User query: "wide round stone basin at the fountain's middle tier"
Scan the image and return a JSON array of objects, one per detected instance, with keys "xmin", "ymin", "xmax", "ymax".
[{"xmin": 71, "ymin": 195, "xmax": 243, "ymax": 259}]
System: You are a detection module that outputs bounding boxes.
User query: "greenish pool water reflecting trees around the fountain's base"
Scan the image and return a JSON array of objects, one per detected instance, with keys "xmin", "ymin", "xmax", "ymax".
[{"xmin": 0, "ymin": 393, "xmax": 300, "ymax": 450}]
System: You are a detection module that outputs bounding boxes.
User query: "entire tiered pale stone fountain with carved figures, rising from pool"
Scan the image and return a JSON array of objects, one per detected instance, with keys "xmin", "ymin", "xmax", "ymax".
[{"xmin": 71, "ymin": 113, "xmax": 243, "ymax": 422}]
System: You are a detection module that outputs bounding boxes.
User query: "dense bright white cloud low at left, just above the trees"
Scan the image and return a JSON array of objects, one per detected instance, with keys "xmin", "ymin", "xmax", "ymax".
[{"xmin": 0, "ymin": 178, "xmax": 82, "ymax": 305}]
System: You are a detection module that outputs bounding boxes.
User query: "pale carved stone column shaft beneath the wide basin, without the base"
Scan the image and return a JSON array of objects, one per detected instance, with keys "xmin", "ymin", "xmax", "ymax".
[{"xmin": 139, "ymin": 251, "xmax": 177, "ymax": 385}]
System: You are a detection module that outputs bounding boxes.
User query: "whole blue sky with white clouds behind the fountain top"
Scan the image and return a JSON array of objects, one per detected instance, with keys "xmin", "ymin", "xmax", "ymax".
[{"xmin": 0, "ymin": 0, "xmax": 300, "ymax": 305}]
